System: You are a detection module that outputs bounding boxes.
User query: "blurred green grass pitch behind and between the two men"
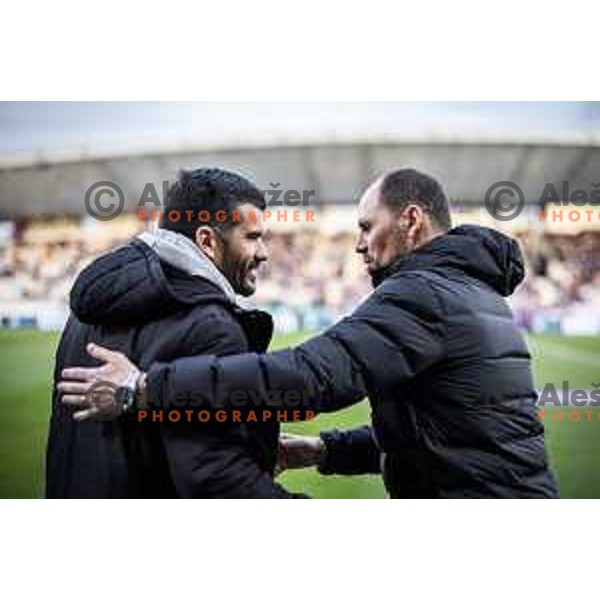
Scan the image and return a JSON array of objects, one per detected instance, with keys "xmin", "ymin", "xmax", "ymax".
[{"xmin": 0, "ymin": 331, "xmax": 600, "ymax": 498}]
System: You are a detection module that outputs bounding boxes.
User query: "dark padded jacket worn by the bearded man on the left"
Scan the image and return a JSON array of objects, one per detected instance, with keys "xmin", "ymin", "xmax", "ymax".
[{"xmin": 46, "ymin": 240, "xmax": 294, "ymax": 498}]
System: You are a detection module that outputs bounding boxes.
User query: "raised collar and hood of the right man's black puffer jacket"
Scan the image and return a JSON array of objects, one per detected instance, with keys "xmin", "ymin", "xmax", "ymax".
[{"xmin": 373, "ymin": 225, "xmax": 525, "ymax": 296}]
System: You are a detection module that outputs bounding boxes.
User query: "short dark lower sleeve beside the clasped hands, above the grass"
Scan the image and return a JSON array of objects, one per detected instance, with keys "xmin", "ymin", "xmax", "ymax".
[{"xmin": 319, "ymin": 426, "xmax": 381, "ymax": 475}]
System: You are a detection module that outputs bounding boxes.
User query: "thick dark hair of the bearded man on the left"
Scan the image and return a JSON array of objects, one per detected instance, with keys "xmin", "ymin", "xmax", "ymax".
[{"xmin": 160, "ymin": 167, "xmax": 266, "ymax": 239}]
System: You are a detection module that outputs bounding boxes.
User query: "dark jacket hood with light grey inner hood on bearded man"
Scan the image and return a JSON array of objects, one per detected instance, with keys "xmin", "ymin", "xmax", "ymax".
[{"xmin": 70, "ymin": 230, "xmax": 236, "ymax": 325}]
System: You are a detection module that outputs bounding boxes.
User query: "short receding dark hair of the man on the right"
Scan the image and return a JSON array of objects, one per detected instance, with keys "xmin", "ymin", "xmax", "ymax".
[{"xmin": 379, "ymin": 168, "xmax": 452, "ymax": 231}]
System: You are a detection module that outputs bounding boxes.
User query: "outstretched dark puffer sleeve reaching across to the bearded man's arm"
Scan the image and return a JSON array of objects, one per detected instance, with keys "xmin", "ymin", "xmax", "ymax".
[{"xmin": 148, "ymin": 276, "xmax": 443, "ymax": 418}]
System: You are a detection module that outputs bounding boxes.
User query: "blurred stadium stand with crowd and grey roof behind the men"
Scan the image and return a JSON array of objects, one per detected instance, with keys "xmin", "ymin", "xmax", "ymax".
[{"xmin": 0, "ymin": 131, "xmax": 600, "ymax": 334}]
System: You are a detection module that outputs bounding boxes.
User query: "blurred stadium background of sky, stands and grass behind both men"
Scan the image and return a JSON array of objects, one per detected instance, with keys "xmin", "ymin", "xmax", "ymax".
[{"xmin": 0, "ymin": 103, "xmax": 600, "ymax": 498}]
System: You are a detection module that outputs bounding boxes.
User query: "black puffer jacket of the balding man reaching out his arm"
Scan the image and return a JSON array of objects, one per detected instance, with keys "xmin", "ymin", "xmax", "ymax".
[{"xmin": 149, "ymin": 226, "xmax": 557, "ymax": 497}]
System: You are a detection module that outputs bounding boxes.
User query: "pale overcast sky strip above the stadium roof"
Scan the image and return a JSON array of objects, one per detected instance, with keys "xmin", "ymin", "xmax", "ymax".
[{"xmin": 0, "ymin": 102, "xmax": 600, "ymax": 154}]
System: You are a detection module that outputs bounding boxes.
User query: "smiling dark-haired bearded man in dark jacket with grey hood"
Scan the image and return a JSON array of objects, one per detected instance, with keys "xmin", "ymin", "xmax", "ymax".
[{"xmin": 46, "ymin": 168, "xmax": 300, "ymax": 498}]
